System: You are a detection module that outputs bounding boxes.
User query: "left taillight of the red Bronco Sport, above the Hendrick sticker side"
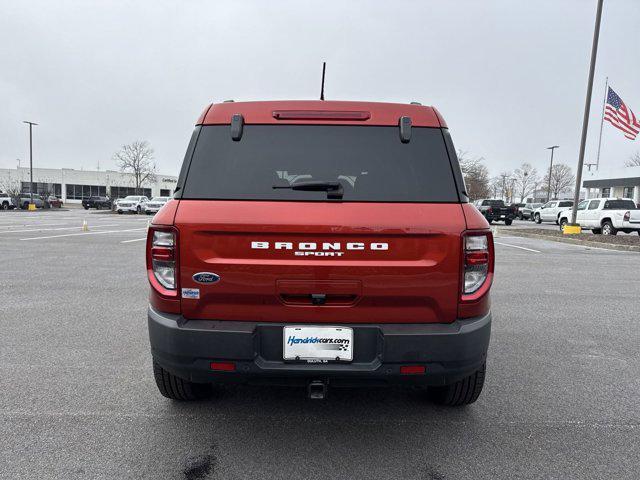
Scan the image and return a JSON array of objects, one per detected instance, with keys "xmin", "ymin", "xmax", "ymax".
[{"xmin": 147, "ymin": 227, "xmax": 178, "ymax": 296}]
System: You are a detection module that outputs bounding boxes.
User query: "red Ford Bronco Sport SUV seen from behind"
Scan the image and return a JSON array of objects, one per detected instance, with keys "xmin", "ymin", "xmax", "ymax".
[{"xmin": 147, "ymin": 101, "xmax": 494, "ymax": 405}]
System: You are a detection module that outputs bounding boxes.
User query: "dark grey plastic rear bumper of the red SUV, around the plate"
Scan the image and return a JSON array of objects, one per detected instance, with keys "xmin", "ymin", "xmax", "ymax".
[{"xmin": 148, "ymin": 307, "xmax": 491, "ymax": 385}]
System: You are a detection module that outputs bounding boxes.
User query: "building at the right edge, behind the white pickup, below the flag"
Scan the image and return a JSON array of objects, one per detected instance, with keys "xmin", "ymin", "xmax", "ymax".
[{"xmin": 582, "ymin": 166, "xmax": 640, "ymax": 204}]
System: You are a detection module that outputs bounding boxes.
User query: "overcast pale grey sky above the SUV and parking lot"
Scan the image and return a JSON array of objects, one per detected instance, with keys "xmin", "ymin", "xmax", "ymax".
[{"xmin": 0, "ymin": 0, "xmax": 640, "ymax": 175}]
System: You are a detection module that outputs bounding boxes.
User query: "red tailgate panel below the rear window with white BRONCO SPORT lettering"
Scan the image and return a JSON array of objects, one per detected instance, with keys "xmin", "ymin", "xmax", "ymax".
[{"xmin": 175, "ymin": 200, "xmax": 465, "ymax": 323}]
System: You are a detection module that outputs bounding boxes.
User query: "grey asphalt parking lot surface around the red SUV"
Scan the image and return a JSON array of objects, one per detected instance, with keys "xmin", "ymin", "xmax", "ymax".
[{"xmin": 0, "ymin": 210, "xmax": 640, "ymax": 480}]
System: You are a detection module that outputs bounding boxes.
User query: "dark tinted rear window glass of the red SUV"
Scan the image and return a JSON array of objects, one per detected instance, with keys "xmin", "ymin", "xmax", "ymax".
[{"xmin": 182, "ymin": 125, "xmax": 460, "ymax": 202}]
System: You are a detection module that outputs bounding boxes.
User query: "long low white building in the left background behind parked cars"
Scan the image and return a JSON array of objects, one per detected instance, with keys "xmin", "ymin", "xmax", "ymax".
[{"xmin": 0, "ymin": 167, "xmax": 178, "ymax": 203}]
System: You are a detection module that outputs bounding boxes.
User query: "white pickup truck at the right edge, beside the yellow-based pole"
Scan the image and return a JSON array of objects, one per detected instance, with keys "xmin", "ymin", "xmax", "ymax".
[{"xmin": 558, "ymin": 198, "xmax": 640, "ymax": 235}]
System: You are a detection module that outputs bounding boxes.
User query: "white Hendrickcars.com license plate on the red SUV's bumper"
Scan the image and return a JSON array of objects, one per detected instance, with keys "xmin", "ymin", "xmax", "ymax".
[{"xmin": 283, "ymin": 326, "xmax": 353, "ymax": 362}]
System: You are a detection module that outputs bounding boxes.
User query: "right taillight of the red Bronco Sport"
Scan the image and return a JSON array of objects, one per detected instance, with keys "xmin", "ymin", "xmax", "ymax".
[{"xmin": 462, "ymin": 232, "xmax": 493, "ymax": 300}]
